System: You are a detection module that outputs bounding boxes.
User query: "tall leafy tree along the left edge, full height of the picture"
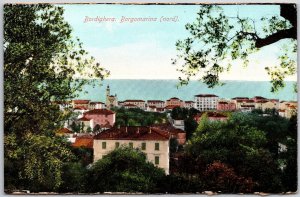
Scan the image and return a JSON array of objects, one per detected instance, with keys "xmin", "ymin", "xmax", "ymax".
[{"xmin": 4, "ymin": 4, "xmax": 108, "ymax": 191}]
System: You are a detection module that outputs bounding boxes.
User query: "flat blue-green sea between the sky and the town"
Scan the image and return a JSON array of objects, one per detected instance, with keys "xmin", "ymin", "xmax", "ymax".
[{"xmin": 77, "ymin": 79, "xmax": 297, "ymax": 102}]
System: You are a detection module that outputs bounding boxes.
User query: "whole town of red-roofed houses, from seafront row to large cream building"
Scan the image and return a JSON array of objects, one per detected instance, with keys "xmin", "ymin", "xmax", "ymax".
[{"xmin": 58, "ymin": 86, "xmax": 297, "ymax": 174}]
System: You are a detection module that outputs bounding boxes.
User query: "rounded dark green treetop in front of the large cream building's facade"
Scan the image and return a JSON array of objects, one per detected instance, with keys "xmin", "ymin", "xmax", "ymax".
[{"xmin": 89, "ymin": 147, "xmax": 165, "ymax": 193}]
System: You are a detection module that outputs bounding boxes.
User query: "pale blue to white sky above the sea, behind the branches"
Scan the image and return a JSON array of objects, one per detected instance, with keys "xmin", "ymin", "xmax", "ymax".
[{"xmin": 63, "ymin": 4, "xmax": 296, "ymax": 81}]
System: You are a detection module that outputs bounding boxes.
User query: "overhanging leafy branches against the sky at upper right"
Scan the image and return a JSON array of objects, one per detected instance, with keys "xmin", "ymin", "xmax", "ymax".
[{"xmin": 173, "ymin": 4, "xmax": 297, "ymax": 92}]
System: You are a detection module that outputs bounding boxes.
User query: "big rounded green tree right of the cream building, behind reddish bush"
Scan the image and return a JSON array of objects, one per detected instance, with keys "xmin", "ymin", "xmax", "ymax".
[{"xmin": 186, "ymin": 115, "xmax": 282, "ymax": 192}]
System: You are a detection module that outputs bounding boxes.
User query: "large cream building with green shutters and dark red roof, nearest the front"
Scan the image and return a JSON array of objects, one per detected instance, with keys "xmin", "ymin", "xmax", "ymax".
[{"xmin": 93, "ymin": 127, "xmax": 170, "ymax": 174}]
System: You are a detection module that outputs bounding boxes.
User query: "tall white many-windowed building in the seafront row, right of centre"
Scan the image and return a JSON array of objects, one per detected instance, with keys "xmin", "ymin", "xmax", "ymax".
[{"xmin": 194, "ymin": 94, "xmax": 219, "ymax": 111}]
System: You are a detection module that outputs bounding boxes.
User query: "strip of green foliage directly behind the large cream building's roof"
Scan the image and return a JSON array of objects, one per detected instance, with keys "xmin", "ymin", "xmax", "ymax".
[{"xmin": 112, "ymin": 107, "xmax": 167, "ymax": 126}]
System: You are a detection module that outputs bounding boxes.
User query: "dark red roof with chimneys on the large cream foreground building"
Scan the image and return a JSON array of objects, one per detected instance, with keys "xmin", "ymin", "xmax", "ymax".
[{"xmin": 94, "ymin": 126, "xmax": 170, "ymax": 141}]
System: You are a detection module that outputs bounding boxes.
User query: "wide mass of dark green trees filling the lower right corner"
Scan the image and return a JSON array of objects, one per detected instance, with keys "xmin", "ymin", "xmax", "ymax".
[{"xmin": 183, "ymin": 113, "xmax": 296, "ymax": 192}]
